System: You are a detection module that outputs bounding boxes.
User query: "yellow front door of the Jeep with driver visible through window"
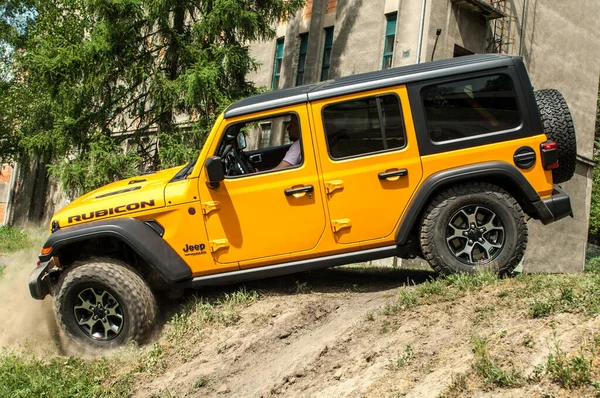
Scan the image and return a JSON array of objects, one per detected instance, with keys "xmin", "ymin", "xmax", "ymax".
[{"xmin": 200, "ymin": 104, "xmax": 325, "ymax": 266}]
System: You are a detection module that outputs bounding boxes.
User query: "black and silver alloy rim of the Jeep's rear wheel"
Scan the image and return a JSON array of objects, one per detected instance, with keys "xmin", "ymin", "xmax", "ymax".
[{"xmin": 446, "ymin": 205, "xmax": 506, "ymax": 266}]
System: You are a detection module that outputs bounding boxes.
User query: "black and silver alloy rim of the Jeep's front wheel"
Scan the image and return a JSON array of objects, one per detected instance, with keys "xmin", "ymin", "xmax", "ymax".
[{"xmin": 73, "ymin": 287, "xmax": 124, "ymax": 341}]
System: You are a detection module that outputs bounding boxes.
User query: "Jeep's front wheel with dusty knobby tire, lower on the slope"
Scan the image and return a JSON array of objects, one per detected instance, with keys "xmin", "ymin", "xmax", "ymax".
[{"xmin": 54, "ymin": 259, "xmax": 158, "ymax": 351}]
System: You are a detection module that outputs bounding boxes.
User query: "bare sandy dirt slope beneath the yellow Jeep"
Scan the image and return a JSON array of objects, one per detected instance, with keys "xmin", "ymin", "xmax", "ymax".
[{"xmin": 127, "ymin": 269, "xmax": 600, "ymax": 397}]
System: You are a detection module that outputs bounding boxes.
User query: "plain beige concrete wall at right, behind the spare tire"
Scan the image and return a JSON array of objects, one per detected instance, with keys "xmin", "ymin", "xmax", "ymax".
[{"xmin": 515, "ymin": 0, "xmax": 600, "ymax": 272}]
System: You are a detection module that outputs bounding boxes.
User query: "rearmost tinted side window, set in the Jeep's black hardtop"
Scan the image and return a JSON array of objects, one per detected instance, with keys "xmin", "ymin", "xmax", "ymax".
[{"xmin": 421, "ymin": 75, "xmax": 521, "ymax": 142}]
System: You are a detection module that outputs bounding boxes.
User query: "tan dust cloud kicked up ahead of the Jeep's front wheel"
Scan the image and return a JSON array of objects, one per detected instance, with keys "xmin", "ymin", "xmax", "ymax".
[{"xmin": 0, "ymin": 245, "xmax": 59, "ymax": 355}]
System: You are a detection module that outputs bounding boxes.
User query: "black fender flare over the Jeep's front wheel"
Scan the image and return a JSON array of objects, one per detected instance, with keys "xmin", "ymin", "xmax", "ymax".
[{"xmin": 40, "ymin": 218, "xmax": 192, "ymax": 283}]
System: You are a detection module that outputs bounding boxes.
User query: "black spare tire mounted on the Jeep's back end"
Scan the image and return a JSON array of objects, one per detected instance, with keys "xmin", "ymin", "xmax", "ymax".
[{"xmin": 534, "ymin": 89, "xmax": 577, "ymax": 184}]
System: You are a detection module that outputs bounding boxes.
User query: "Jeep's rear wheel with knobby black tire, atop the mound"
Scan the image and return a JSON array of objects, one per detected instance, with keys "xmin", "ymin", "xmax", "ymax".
[{"xmin": 420, "ymin": 182, "xmax": 527, "ymax": 275}]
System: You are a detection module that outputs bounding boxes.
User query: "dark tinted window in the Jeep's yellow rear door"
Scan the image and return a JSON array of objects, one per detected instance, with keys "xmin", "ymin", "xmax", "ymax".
[{"xmin": 323, "ymin": 94, "xmax": 406, "ymax": 159}]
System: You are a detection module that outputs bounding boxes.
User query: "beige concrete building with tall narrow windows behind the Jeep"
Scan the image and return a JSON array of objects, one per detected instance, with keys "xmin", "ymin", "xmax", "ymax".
[{"xmin": 249, "ymin": 0, "xmax": 600, "ymax": 272}]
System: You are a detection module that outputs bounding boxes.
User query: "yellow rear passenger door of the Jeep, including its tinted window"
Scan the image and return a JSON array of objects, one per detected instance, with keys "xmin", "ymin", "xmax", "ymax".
[{"xmin": 312, "ymin": 87, "xmax": 423, "ymax": 246}]
